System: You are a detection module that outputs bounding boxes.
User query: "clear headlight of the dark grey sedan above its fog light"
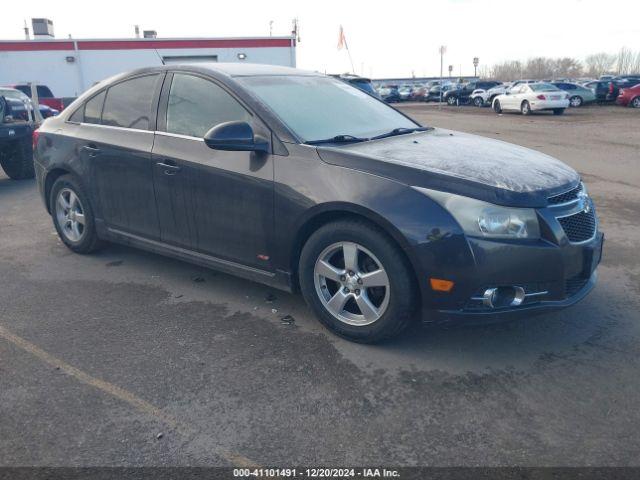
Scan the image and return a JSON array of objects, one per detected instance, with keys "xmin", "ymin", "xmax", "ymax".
[{"xmin": 413, "ymin": 187, "xmax": 540, "ymax": 238}]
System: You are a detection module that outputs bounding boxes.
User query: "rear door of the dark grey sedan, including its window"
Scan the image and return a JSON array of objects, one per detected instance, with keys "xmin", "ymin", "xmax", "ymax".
[{"xmin": 74, "ymin": 73, "xmax": 164, "ymax": 239}]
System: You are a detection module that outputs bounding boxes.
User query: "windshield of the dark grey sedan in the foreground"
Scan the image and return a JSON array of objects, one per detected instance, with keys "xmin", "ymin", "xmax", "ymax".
[{"xmin": 238, "ymin": 75, "xmax": 419, "ymax": 142}]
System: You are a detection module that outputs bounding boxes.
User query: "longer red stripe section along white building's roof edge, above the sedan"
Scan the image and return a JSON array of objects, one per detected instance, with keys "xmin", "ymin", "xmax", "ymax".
[{"xmin": 78, "ymin": 38, "xmax": 291, "ymax": 50}]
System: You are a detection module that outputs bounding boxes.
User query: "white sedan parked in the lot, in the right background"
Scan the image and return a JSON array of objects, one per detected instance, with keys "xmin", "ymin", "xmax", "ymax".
[{"xmin": 492, "ymin": 82, "xmax": 569, "ymax": 115}]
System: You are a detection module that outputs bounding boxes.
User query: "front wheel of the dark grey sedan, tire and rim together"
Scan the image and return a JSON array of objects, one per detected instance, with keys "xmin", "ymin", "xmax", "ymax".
[{"xmin": 298, "ymin": 220, "xmax": 418, "ymax": 343}]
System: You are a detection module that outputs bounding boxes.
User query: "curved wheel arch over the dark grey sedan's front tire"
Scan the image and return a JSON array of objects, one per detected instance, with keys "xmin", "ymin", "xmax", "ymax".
[{"xmin": 289, "ymin": 202, "xmax": 418, "ymax": 289}]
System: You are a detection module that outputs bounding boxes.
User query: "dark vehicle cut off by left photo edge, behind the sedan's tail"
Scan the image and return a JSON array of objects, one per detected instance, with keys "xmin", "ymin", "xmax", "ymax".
[{"xmin": 0, "ymin": 92, "xmax": 37, "ymax": 180}]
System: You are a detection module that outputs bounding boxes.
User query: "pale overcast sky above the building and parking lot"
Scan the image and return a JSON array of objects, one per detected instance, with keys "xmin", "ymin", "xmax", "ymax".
[{"xmin": 0, "ymin": 0, "xmax": 640, "ymax": 78}]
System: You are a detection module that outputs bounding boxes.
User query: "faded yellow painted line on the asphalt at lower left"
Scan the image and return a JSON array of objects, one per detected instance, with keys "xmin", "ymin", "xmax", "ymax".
[{"xmin": 0, "ymin": 325, "xmax": 259, "ymax": 468}]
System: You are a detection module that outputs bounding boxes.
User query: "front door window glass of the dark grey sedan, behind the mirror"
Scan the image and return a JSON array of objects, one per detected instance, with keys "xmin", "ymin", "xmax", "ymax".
[{"xmin": 167, "ymin": 73, "xmax": 251, "ymax": 138}]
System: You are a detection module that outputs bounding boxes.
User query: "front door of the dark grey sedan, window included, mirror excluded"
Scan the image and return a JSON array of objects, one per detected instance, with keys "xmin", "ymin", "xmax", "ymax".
[{"xmin": 153, "ymin": 72, "xmax": 273, "ymax": 270}]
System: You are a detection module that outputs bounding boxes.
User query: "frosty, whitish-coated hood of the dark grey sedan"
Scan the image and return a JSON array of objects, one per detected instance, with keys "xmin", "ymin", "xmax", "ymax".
[{"xmin": 318, "ymin": 129, "xmax": 580, "ymax": 207}]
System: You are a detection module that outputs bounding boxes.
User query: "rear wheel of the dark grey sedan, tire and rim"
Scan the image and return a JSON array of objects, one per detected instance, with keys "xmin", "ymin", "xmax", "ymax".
[{"xmin": 49, "ymin": 175, "xmax": 103, "ymax": 254}]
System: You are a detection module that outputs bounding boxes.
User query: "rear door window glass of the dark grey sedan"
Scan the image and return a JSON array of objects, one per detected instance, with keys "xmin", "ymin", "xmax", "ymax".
[{"xmin": 102, "ymin": 75, "xmax": 160, "ymax": 130}]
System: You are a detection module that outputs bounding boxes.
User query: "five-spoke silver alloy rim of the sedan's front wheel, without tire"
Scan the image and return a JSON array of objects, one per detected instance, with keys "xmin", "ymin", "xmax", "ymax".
[{"xmin": 314, "ymin": 242, "xmax": 390, "ymax": 326}]
